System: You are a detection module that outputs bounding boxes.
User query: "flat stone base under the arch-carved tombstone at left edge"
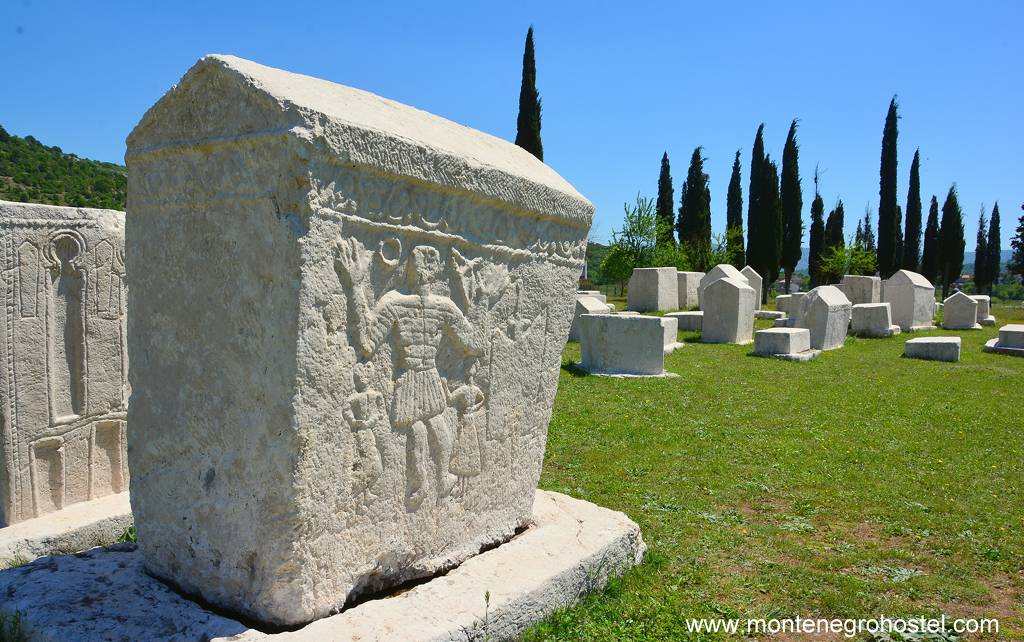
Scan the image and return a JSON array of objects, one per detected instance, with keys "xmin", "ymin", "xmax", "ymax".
[{"xmin": 0, "ymin": 493, "xmax": 132, "ymax": 567}]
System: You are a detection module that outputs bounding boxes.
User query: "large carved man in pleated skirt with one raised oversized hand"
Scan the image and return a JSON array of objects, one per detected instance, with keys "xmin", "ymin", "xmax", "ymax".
[{"xmin": 335, "ymin": 241, "xmax": 483, "ymax": 510}]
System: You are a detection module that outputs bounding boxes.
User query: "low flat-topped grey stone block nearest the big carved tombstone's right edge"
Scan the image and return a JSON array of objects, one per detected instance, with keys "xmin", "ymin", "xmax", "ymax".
[{"xmin": 580, "ymin": 314, "xmax": 675, "ymax": 377}]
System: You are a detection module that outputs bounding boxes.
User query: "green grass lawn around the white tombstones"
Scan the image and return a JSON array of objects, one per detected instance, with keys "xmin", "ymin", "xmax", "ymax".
[{"xmin": 527, "ymin": 300, "xmax": 1024, "ymax": 640}]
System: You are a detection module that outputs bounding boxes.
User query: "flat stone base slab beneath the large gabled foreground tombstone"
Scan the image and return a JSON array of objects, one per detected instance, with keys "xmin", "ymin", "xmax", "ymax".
[{"xmin": 0, "ymin": 490, "xmax": 646, "ymax": 642}]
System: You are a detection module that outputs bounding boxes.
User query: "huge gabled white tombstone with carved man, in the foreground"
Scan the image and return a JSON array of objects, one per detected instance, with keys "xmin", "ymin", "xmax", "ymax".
[{"xmin": 126, "ymin": 56, "xmax": 598, "ymax": 625}]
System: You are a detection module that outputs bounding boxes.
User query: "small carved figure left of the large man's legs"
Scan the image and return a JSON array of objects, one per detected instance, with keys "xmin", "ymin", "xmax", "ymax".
[{"xmin": 342, "ymin": 363, "xmax": 387, "ymax": 505}]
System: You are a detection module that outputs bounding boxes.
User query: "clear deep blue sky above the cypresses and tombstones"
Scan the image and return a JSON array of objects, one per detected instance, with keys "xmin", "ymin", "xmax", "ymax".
[{"xmin": 0, "ymin": 0, "xmax": 1024, "ymax": 251}]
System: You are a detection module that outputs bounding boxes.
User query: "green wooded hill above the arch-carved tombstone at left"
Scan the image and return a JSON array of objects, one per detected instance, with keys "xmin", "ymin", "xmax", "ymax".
[{"xmin": 0, "ymin": 127, "xmax": 128, "ymax": 210}]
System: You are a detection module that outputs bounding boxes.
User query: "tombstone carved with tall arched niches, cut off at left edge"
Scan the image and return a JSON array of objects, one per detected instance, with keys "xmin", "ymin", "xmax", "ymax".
[{"xmin": 0, "ymin": 202, "xmax": 128, "ymax": 526}]
